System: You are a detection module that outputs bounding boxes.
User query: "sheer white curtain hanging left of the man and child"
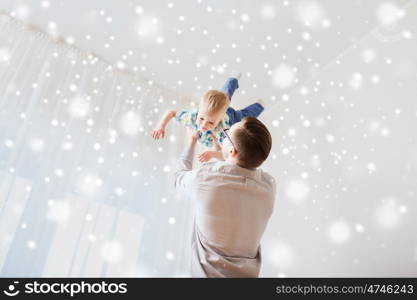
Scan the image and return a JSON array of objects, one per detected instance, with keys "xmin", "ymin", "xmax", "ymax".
[{"xmin": 0, "ymin": 16, "xmax": 190, "ymax": 276}]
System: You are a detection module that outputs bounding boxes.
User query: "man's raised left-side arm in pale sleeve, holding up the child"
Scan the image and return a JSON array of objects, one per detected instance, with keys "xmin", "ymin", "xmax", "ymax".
[{"xmin": 174, "ymin": 128, "xmax": 198, "ymax": 189}]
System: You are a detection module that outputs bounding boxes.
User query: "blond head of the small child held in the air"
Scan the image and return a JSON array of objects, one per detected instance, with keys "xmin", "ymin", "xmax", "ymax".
[{"xmin": 196, "ymin": 90, "xmax": 230, "ymax": 131}]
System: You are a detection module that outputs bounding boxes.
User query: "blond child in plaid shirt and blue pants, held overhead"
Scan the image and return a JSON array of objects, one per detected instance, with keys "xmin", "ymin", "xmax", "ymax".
[{"xmin": 151, "ymin": 76, "xmax": 264, "ymax": 162}]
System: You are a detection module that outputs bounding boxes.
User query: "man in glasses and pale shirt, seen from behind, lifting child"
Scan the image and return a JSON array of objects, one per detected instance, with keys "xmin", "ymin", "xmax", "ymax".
[{"xmin": 175, "ymin": 117, "xmax": 276, "ymax": 277}]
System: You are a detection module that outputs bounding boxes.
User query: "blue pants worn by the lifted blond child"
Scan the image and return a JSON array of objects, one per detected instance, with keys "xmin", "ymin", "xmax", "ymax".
[{"xmin": 222, "ymin": 77, "xmax": 264, "ymax": 126}]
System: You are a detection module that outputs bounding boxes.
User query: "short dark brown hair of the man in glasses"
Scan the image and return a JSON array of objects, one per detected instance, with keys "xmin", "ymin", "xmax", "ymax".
[{"xmin": 233, "ymin": 117, "xmax": 272, "ymax": 169}]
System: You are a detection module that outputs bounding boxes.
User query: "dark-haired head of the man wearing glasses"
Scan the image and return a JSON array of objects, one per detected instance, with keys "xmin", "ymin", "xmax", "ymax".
[{"xmin": 222, "ymin": 117, "xmax": 272, "ymax": 169}]
